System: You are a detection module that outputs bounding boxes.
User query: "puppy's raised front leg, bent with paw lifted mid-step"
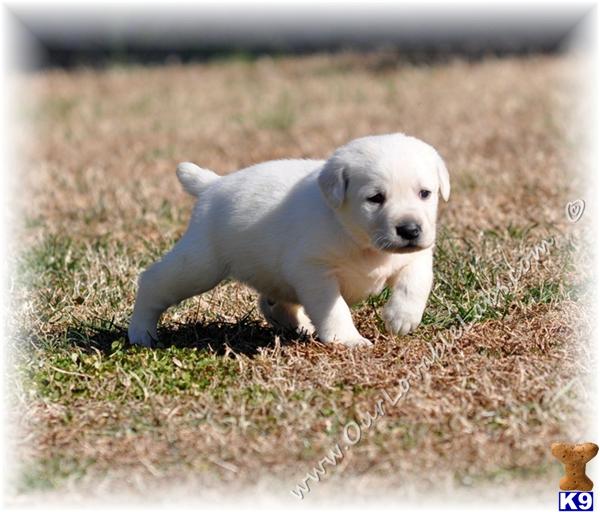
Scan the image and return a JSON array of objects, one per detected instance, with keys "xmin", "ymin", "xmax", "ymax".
[{"xmin": 383, "ymin": 249, "xmax": 433, "ymax": 334}]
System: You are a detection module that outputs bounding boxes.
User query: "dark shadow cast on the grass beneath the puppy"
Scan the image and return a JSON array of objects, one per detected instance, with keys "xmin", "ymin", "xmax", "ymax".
[{"xmin": 67, "ymin": 317, "xmax": 309, "ymax": 356}]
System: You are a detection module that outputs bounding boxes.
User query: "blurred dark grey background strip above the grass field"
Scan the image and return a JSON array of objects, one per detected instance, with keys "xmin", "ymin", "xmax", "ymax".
[{"xmin": 10, "ymin": 3, "xmax": 591, "ymax": 68}]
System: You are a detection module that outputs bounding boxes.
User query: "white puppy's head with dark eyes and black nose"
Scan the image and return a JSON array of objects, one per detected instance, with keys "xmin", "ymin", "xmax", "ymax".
[{"xmin": 319, "ymin": 134, "xmax": 450, "ymax": 253}]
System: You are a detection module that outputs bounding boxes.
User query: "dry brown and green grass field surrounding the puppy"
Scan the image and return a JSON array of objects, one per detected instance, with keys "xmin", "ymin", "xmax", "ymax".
[{"xmin": 9, "ymin": 55, "xmax": 591, "ymax": 500}]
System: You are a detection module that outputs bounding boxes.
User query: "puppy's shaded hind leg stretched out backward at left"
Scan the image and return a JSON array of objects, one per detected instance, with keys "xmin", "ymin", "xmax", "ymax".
[{"xmin": 128, "ymin": 235, "xmax": 226, "ymax": 347}]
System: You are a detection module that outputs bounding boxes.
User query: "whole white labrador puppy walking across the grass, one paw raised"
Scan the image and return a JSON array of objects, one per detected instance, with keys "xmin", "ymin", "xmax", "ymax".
[{"xmin": 129, "ymin": 133, "xmax": 450, "ymax": 347}]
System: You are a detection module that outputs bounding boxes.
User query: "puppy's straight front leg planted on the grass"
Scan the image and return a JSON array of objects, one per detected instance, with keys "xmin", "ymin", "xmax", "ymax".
[{"xmin": 295, "ymin": 268, "xmax": 371, "ymax": 347}]
